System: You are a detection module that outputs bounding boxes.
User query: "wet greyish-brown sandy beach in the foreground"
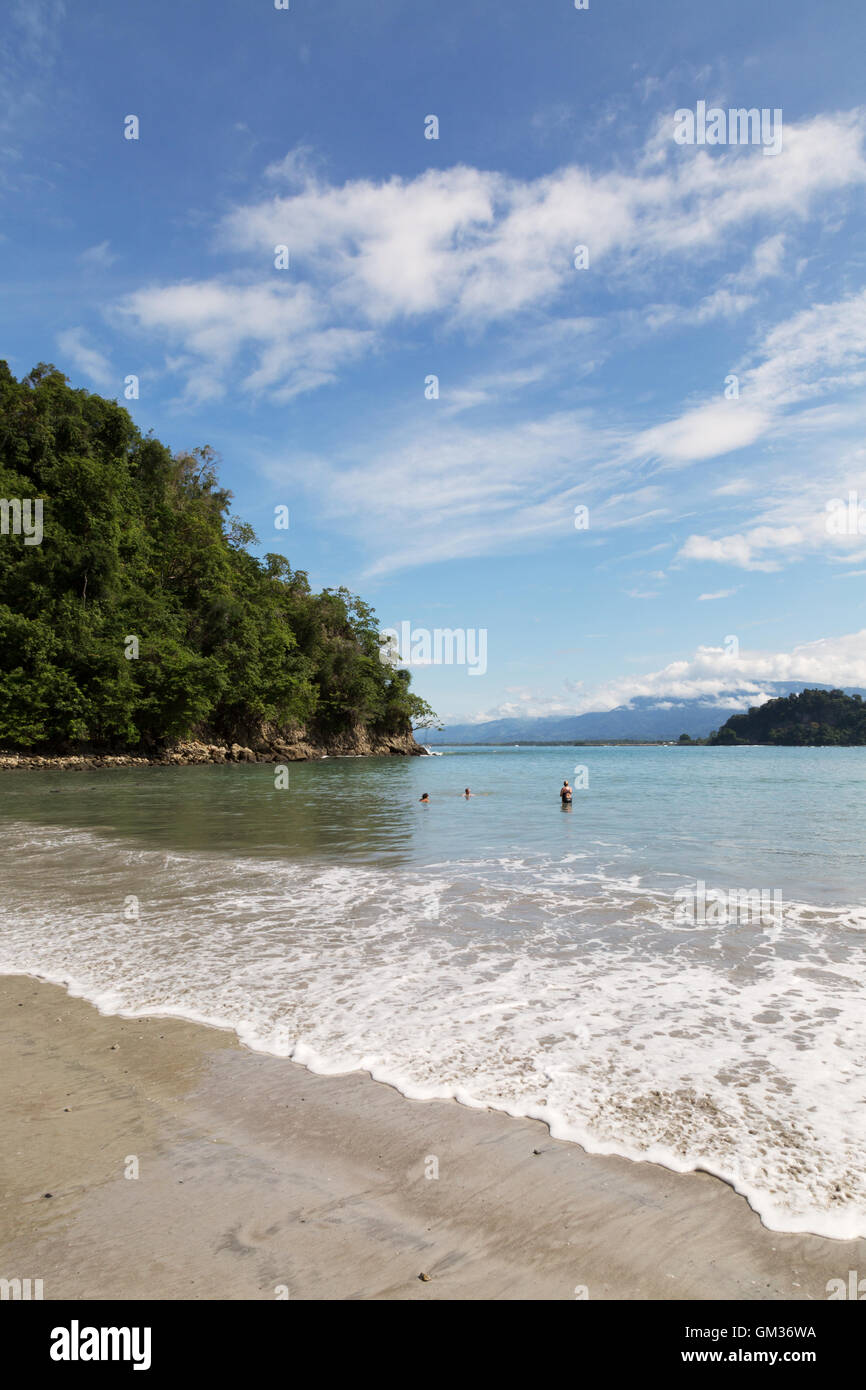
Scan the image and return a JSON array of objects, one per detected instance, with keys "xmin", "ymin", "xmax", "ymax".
[{"xmin": 0, "ymin": 976, "xmax": 866, "ymax": 1300}]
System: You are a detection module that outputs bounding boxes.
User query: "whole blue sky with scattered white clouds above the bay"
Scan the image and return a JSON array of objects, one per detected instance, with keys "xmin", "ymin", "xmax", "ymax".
[{"xmin": 0, "ymin": 0, "xmax": 866, "ymax": 719}]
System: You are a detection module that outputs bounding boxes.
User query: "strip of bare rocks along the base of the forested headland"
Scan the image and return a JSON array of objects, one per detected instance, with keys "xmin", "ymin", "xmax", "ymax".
[{"xmin": 0, "ymin": 726, "xmax": 427, "ymax": 771}]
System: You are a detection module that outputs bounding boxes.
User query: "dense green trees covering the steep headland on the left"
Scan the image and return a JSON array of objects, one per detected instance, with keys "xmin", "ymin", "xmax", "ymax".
[{"xmin": 0, "ymin": 361, "xmax": 431, "ymax": 749}]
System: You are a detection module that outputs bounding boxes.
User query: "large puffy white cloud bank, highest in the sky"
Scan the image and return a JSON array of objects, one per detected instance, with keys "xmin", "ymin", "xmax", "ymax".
[{"xmin": 113, "ymin": 113, "xmax": 866, "ymax": 403}]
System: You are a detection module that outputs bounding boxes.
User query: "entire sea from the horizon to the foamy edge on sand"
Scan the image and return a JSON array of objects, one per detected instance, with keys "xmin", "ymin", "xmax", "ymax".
[{"xmin": 0, "ymin": 748, "xmax": 866, "ymax": 1238}]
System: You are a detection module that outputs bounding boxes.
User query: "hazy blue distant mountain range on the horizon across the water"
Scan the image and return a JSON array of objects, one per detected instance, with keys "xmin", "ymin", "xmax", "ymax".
[{"xmin": 416, "ymin": 681, "xmax": 866, "ymax": 745}]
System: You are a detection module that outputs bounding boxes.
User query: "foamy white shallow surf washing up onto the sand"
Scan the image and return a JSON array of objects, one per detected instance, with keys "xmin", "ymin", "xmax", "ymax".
[{"xmin": 0, "ymin": 823, "xmax": 866, "ymax": 1238}]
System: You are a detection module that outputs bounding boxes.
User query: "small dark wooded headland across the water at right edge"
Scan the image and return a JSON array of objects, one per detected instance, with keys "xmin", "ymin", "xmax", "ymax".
[{"xmin": 709, "ymin": 689, "xmax": 866, "ymax": 745}]
